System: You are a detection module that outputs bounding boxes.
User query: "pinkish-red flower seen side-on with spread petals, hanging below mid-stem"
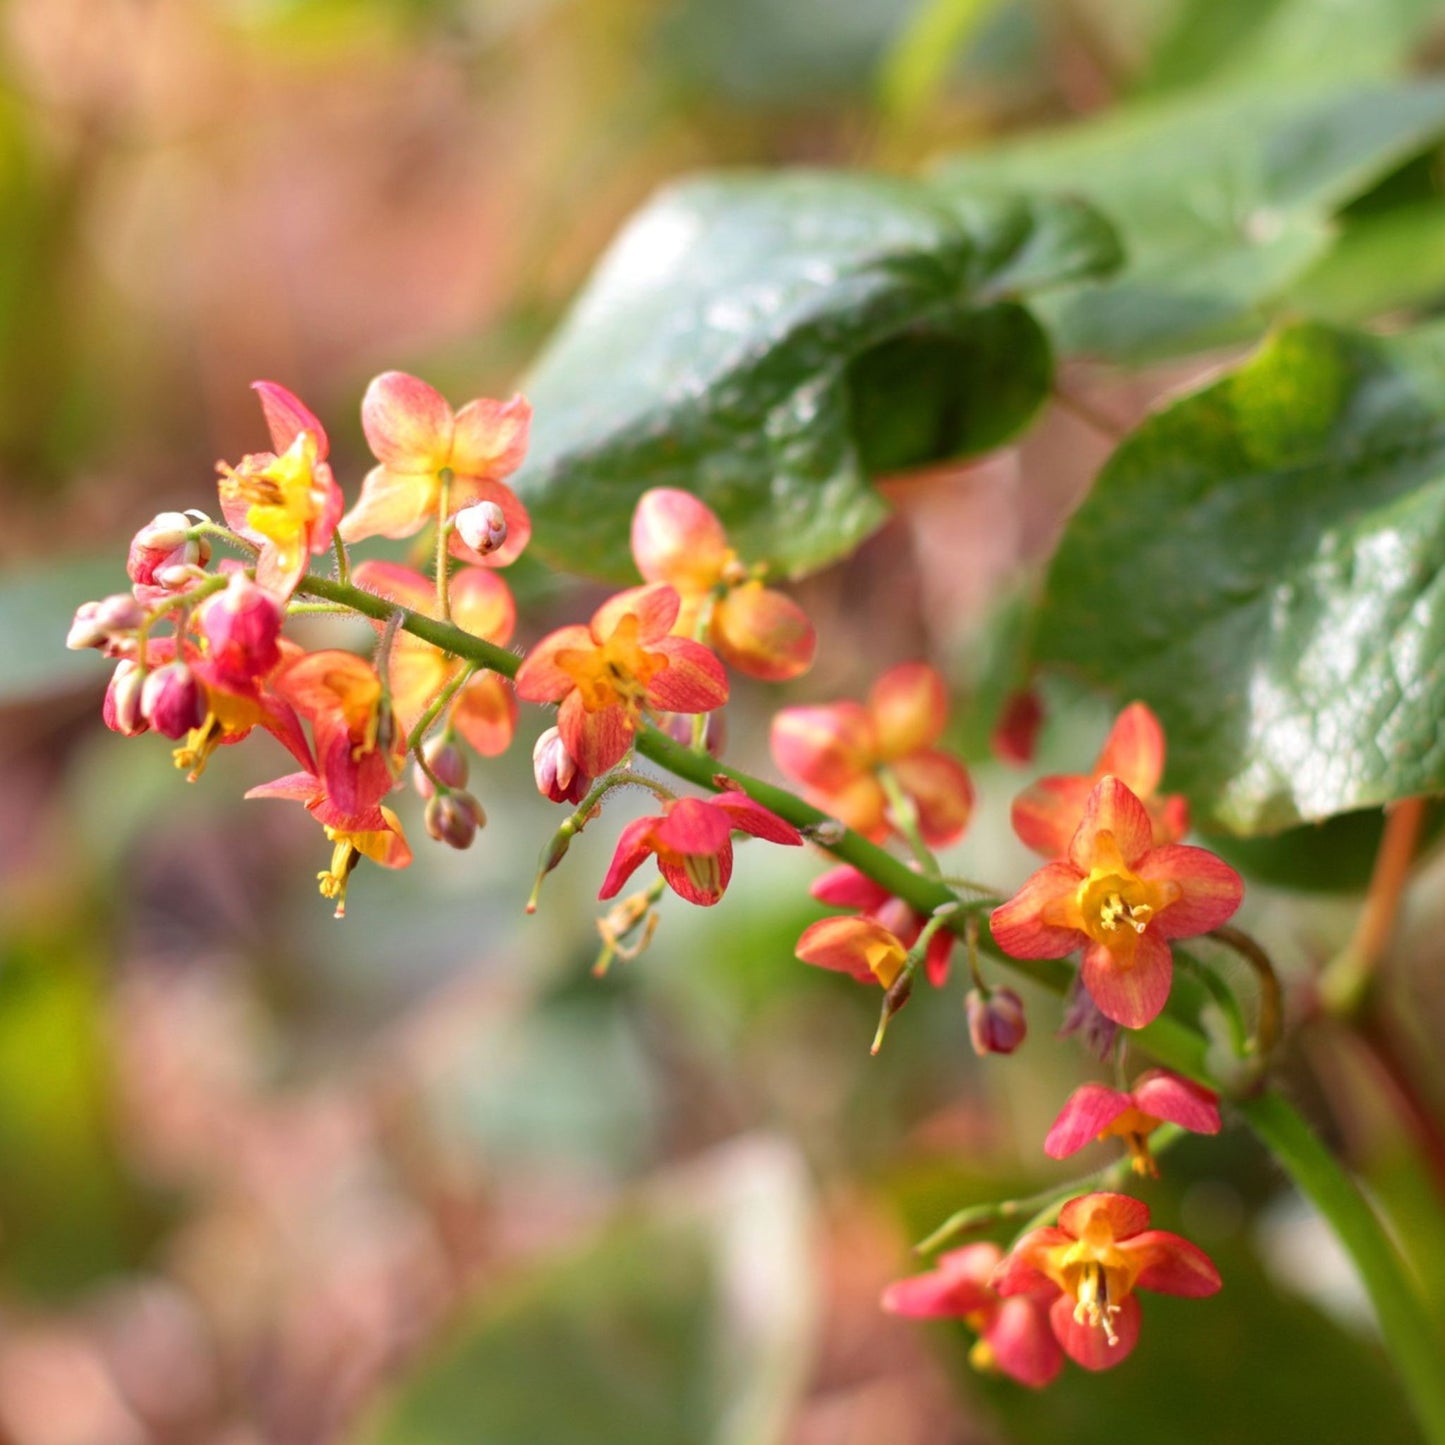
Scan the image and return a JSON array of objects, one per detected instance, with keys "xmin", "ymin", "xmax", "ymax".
[{"xmin": 597, "ymin": 789, "xmax": 803, "ymax": 907}]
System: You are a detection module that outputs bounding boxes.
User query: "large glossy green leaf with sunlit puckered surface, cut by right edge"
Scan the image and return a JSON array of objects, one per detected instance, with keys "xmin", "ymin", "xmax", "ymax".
[{"xmin": 1036, "ymin": 316, "xmax": 1445, "ymax": 834}]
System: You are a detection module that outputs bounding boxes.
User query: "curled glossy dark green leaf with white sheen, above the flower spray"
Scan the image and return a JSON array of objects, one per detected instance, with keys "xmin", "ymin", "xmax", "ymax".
[{"xmin": 516, "ymin": 171, "xmax": 1117, "ymax": 581}]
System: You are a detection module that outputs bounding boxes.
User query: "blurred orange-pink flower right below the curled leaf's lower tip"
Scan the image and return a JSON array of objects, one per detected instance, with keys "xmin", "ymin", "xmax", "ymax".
[{"xmin": 631, "ymin": 487, "xmax": 818, "ymax": 682}]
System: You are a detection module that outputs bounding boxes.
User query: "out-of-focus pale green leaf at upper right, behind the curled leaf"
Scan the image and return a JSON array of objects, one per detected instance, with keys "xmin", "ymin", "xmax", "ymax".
[{"xmin": 938, "ymin": 82, "xmax": 1445, "ymax": 361}]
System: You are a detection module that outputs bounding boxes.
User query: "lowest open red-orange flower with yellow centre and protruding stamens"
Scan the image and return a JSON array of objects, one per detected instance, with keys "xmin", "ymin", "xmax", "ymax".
[{"xmin": 993, "ymin": 1194, "xmax": 1220, "ymax": 1370}]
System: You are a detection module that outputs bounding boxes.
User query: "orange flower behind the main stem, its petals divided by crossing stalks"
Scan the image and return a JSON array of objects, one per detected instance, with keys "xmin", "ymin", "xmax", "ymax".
[{"xmin": 351, "ymin": 561, "xmax": 517, "ymax": 757}]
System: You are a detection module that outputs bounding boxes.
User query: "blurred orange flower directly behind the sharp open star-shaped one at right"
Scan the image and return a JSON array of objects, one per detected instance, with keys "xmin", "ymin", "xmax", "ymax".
[{"xmin": 1013, "ymin": 702, "xmax": 1189, "ymax": 858}]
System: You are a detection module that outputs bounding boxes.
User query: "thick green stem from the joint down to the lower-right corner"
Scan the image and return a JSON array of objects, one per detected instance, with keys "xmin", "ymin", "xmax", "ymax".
[{"xmin": 1238, "ymin": 1092, "xmax": 1445, "ymax": 1445}]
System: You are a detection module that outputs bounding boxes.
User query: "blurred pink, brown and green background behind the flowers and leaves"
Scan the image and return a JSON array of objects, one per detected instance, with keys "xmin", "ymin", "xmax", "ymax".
[{"xmin": 8, "ymin": 0, "xmax": 1445, "ymax": 1445}]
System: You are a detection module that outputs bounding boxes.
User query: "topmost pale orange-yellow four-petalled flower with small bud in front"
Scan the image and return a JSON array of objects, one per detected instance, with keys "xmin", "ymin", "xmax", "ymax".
[{"xmin": 341, "ymin": 371, "xmax": 532, "ymax": 566}]
